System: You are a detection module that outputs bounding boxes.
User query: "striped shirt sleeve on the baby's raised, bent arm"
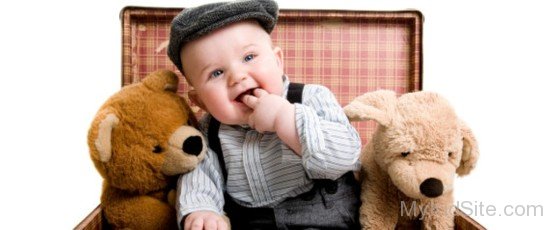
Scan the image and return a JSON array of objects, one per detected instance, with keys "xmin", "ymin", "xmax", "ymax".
[{"xmin": 295, "ymin": 84, "xmax": 361, "ymax": 180}]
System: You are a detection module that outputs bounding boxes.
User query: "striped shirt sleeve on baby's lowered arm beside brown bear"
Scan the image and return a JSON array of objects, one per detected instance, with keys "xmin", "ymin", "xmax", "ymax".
[{"xmin": 176, "ymin": 116, "xmax": 224, "ymax": 228}]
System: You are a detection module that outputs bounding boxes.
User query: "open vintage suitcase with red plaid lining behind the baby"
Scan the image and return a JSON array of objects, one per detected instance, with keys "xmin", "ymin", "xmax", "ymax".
[{"xmin": 76, "ymin": 7, "xmax": 484, "ymax": 229}]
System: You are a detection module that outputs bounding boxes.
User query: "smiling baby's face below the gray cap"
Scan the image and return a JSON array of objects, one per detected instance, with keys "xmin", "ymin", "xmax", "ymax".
[{"xmin": 180, "ymin": 21, "xmax": 283, "ymax": 125}]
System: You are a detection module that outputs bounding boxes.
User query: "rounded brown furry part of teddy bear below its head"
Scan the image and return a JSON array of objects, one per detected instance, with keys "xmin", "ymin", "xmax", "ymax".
[{"xmin": 105, "ymin": 195, "xmax": 177, "ymax": 229}]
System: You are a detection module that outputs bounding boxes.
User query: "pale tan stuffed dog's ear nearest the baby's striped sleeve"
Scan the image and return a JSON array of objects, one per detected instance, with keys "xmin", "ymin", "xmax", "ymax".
[{"xmin": 344, "ymin": 90, "xmax": 397, "ymax": 126}]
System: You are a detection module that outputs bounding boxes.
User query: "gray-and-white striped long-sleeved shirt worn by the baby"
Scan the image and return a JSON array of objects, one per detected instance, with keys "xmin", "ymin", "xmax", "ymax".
[{"xmin": 176, "ymin": 77, "xmax": 361, "ymax": 223}]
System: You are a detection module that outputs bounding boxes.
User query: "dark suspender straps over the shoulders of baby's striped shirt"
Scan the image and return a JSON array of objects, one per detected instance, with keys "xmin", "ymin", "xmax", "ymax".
[{"xmin": 208, "ymin": 82, "xmax": 304, "ymax": 181}]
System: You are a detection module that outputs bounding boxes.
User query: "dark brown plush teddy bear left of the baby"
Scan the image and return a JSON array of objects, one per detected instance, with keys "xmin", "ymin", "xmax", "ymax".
[{"xmin": 88, "ymin": 70, "xmax": 206, "ymax": 229}]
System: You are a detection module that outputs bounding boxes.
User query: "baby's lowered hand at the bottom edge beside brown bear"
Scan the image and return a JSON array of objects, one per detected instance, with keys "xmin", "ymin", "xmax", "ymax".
[{"xmin": 183, "ymin": 211, "xmax": 230, "ymax": 230}]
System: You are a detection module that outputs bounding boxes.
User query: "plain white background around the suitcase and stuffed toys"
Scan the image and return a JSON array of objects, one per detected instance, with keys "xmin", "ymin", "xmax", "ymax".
[{"xmin": 0, "ymin": 0, "xmax": 550, "ymax": 229}]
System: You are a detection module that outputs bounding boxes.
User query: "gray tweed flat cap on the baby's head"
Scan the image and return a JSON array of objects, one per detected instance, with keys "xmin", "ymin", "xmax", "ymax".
[{"xmin": 168, "ymin": 0, "xmax": 279, "ymax": 73}]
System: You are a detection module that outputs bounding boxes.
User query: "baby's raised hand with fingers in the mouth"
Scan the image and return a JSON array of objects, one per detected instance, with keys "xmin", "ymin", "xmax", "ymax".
[{"xmin": 243, "ymin": 88, "xmax": 294, "ymax": 132}]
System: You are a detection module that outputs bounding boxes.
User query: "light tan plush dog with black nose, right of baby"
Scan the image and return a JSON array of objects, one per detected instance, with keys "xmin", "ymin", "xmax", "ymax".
[{"xmin": 344, "ymin": 90, "xmax": 479, "ymax": 229}]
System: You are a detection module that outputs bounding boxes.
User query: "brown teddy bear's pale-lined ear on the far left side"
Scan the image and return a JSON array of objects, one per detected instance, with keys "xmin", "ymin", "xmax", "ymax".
[{"xmin": 90, "ymin": 112, "xmax": 119, "ymax": 162}]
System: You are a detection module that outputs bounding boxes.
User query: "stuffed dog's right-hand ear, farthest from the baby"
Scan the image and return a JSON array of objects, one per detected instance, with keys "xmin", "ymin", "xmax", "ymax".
[{"xmin": 456, "ymin": 121, "xmax": 479, "ymax": 176}]
